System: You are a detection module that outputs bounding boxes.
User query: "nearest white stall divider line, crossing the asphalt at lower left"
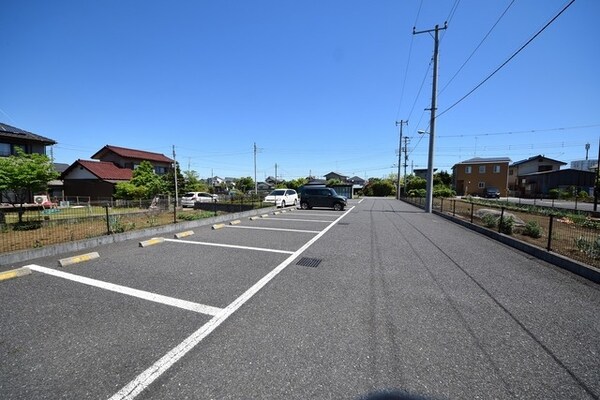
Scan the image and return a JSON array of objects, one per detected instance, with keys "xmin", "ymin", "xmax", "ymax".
[{"xmin": 27, "ymin": 264, "xmax": 223, "ymax": 316}]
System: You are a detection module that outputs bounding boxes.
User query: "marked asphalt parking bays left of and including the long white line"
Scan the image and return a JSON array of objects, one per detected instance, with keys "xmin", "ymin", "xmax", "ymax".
[{"xmin": 0, "ymin": 205, "xmax": 349, "ymax": 399}]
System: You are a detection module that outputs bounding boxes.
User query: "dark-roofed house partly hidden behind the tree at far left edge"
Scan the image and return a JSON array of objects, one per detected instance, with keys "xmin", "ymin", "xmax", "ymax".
[{"xmin": 0, "ymin": 123, "xmax": 56, "ymax": 203}]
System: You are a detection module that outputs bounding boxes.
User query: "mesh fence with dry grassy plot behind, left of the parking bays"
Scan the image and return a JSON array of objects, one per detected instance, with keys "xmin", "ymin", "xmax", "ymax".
[{"xmin": 0, "ymin": 198, "xmax": 271, "ymax": 253}]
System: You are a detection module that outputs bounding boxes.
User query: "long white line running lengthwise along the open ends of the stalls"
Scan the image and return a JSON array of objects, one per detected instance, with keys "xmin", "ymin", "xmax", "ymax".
[{"xmin": 109, "ymin": 207, "xmax": 354, "ymax": 400}]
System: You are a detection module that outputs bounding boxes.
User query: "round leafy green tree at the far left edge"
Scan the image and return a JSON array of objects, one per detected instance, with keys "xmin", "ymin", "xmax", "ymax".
[{"xmin": 0, "ymin": 148, "xmax": 59, "ymax": 223}]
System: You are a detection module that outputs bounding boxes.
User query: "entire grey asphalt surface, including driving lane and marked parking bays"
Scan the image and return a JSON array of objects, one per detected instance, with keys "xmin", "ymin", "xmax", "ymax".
[{"xmin": 0, "ymin": 198, "xmax": 600, "ymax": 400}]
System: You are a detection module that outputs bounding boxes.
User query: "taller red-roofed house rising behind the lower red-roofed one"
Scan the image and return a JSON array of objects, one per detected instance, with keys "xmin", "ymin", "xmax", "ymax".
[{"xmin": 92, "ymin": 145, "xmax": 173, "ymax": 175}]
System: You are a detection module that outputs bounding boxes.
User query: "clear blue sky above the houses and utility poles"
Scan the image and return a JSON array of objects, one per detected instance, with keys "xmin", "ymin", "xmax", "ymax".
[{"xmin": 0, "ymin": 0, "xmax": 600, "ymax": 181}]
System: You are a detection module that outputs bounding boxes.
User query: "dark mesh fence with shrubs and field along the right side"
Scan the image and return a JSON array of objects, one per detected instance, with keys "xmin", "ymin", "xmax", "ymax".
[{"xmin": 403, "ymin": 197, "xmax": 600, "ymax": 268}]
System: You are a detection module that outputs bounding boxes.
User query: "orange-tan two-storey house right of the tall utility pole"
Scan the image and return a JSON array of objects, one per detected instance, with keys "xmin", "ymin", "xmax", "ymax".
[{"xmin": 452, "ymin": 157, "xmax": 510, "ymax": 197}]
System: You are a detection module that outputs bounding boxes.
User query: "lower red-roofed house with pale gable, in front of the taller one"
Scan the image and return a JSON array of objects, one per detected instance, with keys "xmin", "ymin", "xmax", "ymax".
[{"xmin": 61, "ymin": 160, "xmax": 133, "ymax": 201}]
